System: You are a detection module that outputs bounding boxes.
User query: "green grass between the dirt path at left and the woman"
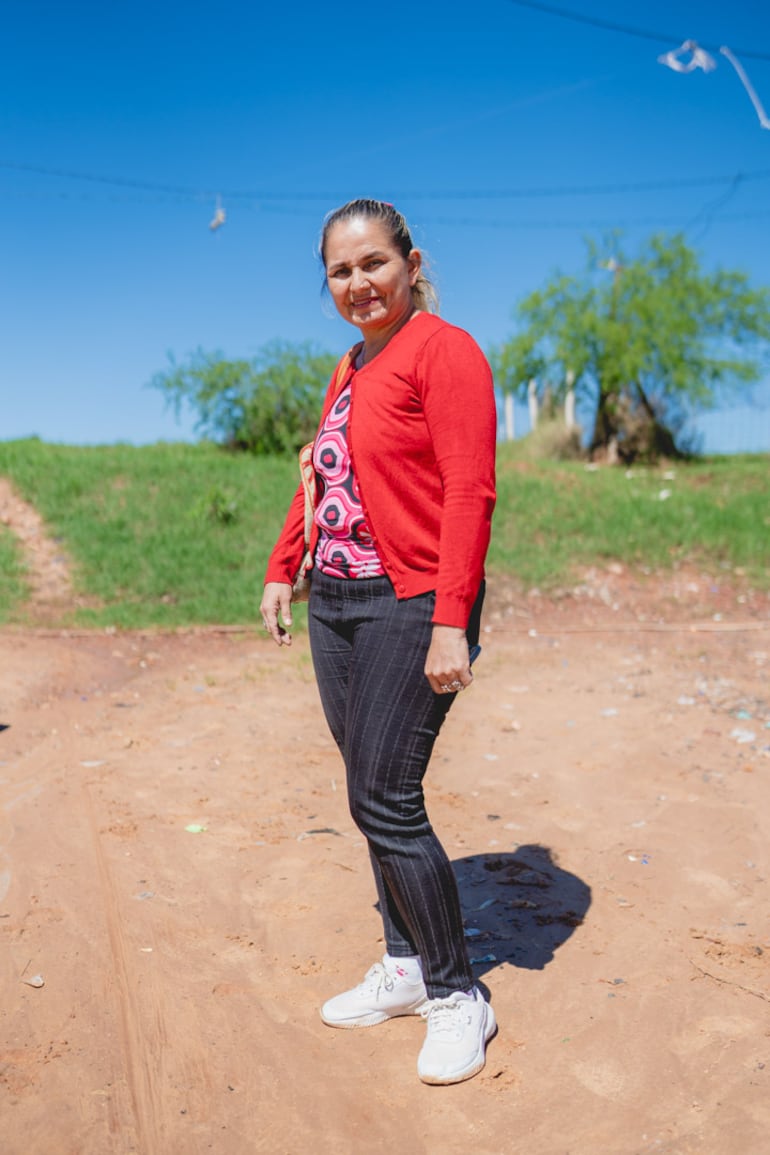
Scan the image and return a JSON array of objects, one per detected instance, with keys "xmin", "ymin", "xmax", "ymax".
[{"xmin": 0, "ymin": 440, "xmax": 299, "ymax": 628}]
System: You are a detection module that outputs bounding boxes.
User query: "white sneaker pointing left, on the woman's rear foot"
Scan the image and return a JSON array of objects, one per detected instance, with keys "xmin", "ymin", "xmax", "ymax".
[{"xmin": 321, "ymin": 954, "xmax": 428, "ymax": 1027}]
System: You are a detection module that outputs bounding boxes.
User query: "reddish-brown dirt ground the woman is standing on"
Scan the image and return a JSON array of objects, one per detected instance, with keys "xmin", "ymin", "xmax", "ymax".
[{"xmin": 0, "ymin": 475, "xmax": 770, "ymax": 1155}]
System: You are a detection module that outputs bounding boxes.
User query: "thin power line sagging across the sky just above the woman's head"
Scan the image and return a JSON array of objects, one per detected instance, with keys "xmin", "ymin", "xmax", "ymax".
[{"xmin": 0, "ymin": 161, "xmax": 770, "ymax": 203}]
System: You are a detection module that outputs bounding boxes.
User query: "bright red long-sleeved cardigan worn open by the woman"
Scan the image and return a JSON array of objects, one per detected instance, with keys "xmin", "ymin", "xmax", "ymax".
[{"xmin": 266, "ymin": 313, "xmax": 498, "ymax": 629}]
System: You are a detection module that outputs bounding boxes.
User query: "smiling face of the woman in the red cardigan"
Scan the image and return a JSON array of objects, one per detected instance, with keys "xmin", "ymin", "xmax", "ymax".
[{"xmin": 326, "ymin": 217, "xmax": 421, "ymax": 337}]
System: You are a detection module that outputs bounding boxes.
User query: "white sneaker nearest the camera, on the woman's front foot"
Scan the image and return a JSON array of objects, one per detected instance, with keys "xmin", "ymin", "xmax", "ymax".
[{"xmin": 417, "ymin": 986, "xmax": 498, "ymax": 1085}]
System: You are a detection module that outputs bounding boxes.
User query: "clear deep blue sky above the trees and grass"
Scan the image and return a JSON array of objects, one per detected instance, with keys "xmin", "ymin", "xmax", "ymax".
[{"xmin": 0, "ymin": 0, "xmax": 770, "ymax": 450}]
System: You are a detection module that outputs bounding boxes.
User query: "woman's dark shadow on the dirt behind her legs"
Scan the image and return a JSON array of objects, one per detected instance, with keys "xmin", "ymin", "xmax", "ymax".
[{"xmin": 453, "ymin": 843, "xmax": 591, "ymax": 976}]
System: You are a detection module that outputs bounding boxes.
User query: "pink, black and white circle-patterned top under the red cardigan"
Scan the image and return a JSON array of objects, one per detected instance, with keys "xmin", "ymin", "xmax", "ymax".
[{"xmin": 313, "ymin": 383, "xmax": 386, "ymax": 578}]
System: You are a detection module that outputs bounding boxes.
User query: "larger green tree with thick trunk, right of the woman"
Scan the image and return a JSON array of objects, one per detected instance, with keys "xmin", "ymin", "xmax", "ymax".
[{"xmin": 492, "ymin": 234, "xmax": 770, "ymax": 461}]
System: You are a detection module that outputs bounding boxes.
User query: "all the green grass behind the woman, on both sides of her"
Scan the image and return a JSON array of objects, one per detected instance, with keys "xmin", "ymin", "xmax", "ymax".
[{"xmin": 0, "ymin": 440, "xmax": 770, "ymax": 628}]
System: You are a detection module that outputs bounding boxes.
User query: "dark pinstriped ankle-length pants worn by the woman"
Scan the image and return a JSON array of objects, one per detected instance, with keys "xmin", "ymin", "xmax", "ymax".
[{"xmin": 308, "ymin": 569, "xmax": 484, "ymax": 998}]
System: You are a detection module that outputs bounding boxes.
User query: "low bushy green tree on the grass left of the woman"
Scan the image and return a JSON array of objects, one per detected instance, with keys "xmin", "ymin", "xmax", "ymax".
[{"xmin": 150, "ymin": 341, "xmax": 336, "ymax": 454}]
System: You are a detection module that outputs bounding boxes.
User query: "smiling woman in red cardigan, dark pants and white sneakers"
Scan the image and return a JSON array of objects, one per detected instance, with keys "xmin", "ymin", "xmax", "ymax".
[{"xmin": 261, "ymin": 200, "xmax": 496, "ymax": 1083}]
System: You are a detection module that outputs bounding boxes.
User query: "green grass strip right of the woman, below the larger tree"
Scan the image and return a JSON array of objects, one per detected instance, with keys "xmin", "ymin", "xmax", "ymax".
[{"xmin": 489, "ymin": 444, "xmax": 770, "ymax": 589}]
